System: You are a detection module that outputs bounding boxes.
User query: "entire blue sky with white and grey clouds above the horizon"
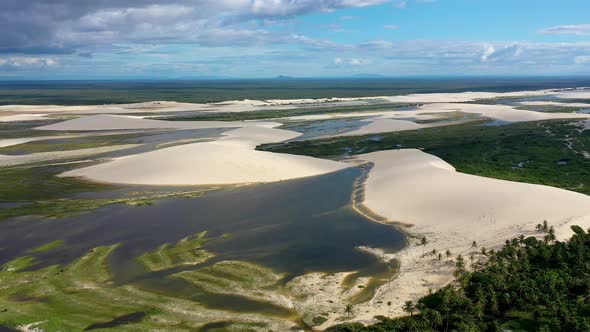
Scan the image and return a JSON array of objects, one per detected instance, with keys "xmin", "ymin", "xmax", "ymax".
[{"xmin": 0, "ymin": 0, "xmax": 590, "ymax": 80}]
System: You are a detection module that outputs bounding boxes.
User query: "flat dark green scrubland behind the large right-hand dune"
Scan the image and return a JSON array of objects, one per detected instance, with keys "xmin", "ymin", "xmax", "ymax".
[{"xmin": 258, "ymin": 121, "xmax": 590, "ymax": 194}]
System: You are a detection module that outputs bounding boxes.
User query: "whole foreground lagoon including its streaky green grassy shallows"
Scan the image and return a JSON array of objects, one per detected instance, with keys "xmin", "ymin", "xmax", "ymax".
[{"xmin": 0, "ymin": 168, "xmax": 405, "ymax": 330}]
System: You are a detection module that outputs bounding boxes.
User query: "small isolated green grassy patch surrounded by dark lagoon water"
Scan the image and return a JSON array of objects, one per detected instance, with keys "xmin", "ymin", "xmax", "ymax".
[{"xmin": 137, "ymin": 232, "xmax": 213, "ymax": 271}]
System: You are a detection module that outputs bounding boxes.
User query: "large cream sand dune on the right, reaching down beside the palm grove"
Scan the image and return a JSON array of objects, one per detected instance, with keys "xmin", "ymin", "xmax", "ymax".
[{"xmin": 358, "ymin": 150, "xmax": 590, "ymax": 319}]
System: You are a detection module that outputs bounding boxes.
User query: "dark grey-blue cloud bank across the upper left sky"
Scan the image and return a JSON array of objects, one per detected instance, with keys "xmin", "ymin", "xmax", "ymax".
[{"xmin": 0, "ymin": 0, "xmax": 389, "ymax": 54}]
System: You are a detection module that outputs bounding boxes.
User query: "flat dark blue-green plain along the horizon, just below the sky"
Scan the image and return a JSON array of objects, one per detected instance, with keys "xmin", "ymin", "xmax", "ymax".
[{"xmin": 0, "ymin": 77, "xmax": 590, "ymax": 105}]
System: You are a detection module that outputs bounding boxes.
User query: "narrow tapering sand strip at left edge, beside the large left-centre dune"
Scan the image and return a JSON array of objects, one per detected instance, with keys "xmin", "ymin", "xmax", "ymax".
[{"xmin": 0, "ymin": 144, "xmax": 140, "ymax": 166}]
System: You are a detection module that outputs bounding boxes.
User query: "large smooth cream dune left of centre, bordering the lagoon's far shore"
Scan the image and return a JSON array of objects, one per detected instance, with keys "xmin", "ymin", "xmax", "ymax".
[{"xmin": 62, "ymin": 127, "xmax": 350, "ymax": 185}]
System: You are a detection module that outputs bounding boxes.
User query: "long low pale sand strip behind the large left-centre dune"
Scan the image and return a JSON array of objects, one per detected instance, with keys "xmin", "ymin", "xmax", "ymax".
[{"xmin": 35, "ymin": 115, "xmax": 281, "ymax": 131}]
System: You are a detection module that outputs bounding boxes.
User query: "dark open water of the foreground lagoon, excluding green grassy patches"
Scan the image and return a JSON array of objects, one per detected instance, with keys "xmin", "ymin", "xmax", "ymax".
[{"xmin": 0, "ymin": 168, "xmax": 405, "ymax": 315}]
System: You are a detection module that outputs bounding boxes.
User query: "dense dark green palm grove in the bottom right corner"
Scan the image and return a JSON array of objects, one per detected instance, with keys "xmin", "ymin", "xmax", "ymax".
[{"xmin": 328, "ymin": 226, "xmax": 590, "ymax": 332}]
